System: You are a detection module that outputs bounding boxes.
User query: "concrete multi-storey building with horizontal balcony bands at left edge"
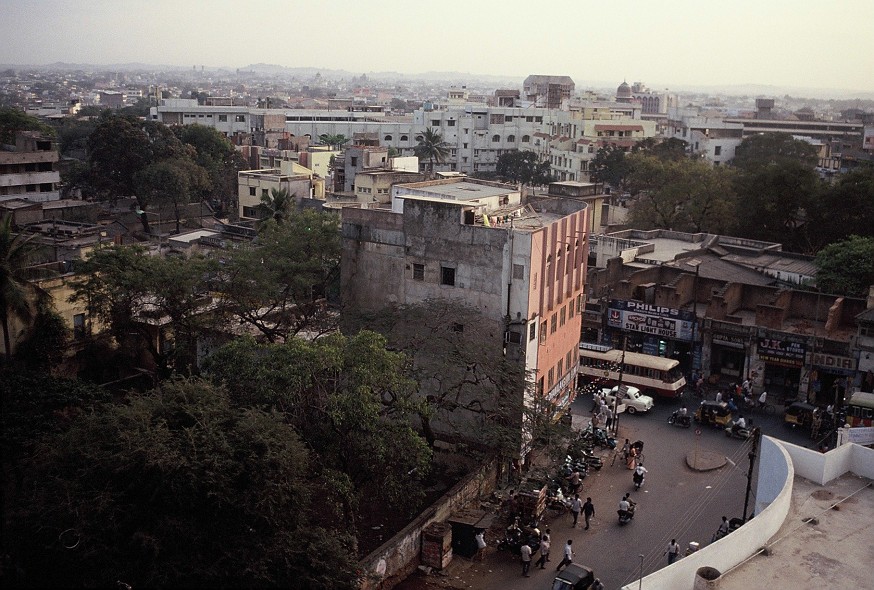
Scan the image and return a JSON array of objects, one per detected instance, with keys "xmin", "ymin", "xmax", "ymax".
[{"xmin": 0, "ymin": 131, "xmax": 61, "ymax": 202}]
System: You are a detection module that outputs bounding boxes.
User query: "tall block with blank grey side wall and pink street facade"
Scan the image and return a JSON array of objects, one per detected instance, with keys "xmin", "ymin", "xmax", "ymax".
[{"xmin": 341, "ymin": 178, "xmax": 589, "ymax": 453}]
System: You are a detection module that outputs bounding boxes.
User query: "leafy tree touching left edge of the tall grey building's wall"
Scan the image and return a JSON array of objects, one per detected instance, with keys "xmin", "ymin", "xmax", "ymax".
[{"xmin": 213, "ymin": 210, "xmax": 341, "ymax": 342}]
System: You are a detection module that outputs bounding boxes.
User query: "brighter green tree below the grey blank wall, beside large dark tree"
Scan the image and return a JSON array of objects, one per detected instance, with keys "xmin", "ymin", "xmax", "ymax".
[{"xmin": 207, "ymin": 332, "xmax": 431, "ymax": 510}]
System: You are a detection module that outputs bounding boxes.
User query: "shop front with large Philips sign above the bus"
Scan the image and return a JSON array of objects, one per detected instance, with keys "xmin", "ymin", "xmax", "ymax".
[{"xmin": 607, "ymin": 300, "xmax": 701, "ymax": 373}]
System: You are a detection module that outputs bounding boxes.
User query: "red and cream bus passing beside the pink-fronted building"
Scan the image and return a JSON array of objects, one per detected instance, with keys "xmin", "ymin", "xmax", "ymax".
[{"xmin": 580, "ymin": 342, "xmax": 686, "ymax": 397}]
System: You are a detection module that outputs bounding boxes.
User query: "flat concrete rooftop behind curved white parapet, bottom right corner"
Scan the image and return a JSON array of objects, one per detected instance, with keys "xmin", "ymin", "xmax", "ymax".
[{"xmin": 719, "ymin": 473, "xmax": 874, "ymax": 590}]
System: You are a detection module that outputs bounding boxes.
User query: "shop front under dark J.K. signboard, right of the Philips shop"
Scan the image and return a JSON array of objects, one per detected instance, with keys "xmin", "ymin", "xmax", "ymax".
[{"xmin": 750, "ymin": 334, "xmax": 807, "ymax": 399}]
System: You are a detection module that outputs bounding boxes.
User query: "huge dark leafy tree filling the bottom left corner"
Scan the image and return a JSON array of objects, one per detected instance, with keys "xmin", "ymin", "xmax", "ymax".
[{"xmin": 3, "ymin": 381, "xmax": 357, "ymax": 590}]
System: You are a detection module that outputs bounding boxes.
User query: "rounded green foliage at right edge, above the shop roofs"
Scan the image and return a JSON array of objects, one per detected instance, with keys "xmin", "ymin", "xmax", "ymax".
[{"xmin": 815, "ymin": 236, "xmax": 874, "ymax": 297}]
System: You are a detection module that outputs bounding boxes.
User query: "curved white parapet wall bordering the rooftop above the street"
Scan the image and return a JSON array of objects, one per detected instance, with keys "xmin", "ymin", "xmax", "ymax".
[{"xmin": 623, "ymin": 436, "xmax": 795, "ymax": 590}]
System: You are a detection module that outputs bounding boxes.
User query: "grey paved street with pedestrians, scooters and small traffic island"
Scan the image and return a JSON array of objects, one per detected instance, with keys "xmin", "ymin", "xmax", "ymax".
[{"xmin": 405, "ymin": 397, "xmax": 811, "ymax": 590}]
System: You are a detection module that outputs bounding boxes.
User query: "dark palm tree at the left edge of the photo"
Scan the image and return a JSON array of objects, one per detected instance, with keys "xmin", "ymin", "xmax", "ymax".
[{"xmin": 0, "ymin": 215, "xmax": 36, "ymax": 363}]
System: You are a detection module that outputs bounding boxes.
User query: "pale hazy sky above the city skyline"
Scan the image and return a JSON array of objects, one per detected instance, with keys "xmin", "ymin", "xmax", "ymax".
[{"xmin": 0, "ymin": 0, "xmax": 874, "ymax": 91}]
